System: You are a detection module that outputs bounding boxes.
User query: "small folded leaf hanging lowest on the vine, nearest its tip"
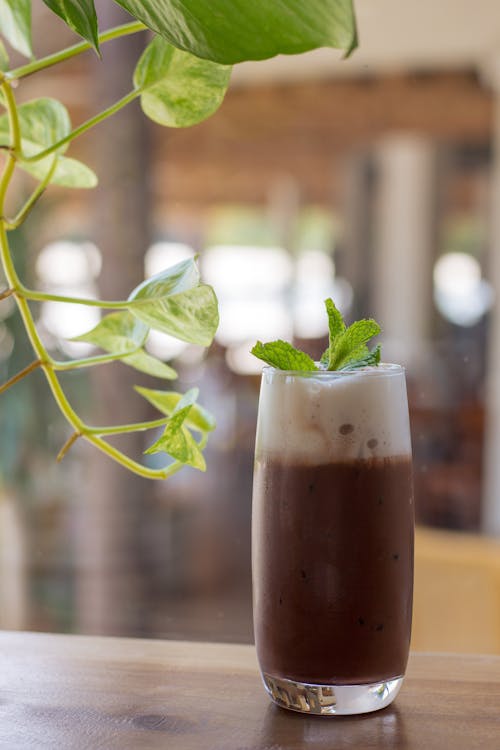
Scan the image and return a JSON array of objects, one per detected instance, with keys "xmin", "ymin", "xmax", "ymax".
[{"xmin": 145, "ymin": 388, "xmax": 206, "ymax": 471}]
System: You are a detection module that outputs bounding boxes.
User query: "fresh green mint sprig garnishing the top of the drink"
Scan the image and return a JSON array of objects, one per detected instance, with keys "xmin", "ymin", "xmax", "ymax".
[{"xmin": 252, "ymin": 299, "xmax": 381, "ymax": 372}]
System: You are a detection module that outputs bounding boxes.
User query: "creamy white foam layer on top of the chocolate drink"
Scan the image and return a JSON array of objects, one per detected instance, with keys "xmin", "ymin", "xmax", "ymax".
[{"xmin": 256, "ymin": 365, "xmax": 411, "ymax": 464}]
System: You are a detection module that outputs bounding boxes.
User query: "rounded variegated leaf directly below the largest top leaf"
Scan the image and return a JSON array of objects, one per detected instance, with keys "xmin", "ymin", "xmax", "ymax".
[{"xmin": 134, "ymin": 36, "xmax": 231, "ymax": 128}]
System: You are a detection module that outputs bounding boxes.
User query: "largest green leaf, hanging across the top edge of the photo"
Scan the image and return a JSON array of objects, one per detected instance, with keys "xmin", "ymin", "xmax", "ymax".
[{"xmin": 116, "ymin": 0, "xmax": 357, "ymax": 64}]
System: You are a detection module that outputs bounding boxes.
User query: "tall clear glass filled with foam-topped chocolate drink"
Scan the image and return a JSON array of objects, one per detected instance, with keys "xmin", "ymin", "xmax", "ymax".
[{"xmin": 252, "ymin": 364, "xmax": 414, "ymax": 714}]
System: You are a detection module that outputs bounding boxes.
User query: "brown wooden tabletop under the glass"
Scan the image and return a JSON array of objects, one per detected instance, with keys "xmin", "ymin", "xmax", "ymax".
[{"xmin": 0, "ymin": 633, "xmax": 500, "ymax": 750}]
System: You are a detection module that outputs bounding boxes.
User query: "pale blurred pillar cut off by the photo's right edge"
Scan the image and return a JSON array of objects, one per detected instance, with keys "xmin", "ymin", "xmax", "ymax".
[{"xmin": 481, "ymin": 57, "xmax": 500, "ymax": 536}]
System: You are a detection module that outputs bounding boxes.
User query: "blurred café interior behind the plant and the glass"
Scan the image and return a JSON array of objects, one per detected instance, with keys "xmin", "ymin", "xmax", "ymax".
[{"xmin": 0, "ymin": 0, "xmax": 500, "ymax": 653}]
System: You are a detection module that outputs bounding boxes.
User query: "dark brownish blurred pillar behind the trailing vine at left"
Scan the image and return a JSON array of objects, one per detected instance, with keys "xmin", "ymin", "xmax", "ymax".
[{"xmin": 77, "ymin": 2, "xmax": 152, "ymax": 635}]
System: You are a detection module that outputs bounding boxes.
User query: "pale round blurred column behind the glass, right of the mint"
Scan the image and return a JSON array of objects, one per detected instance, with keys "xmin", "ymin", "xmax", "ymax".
[{"xmin": 373, "ymin": 135, "xmax": 436, "ymax": 365}]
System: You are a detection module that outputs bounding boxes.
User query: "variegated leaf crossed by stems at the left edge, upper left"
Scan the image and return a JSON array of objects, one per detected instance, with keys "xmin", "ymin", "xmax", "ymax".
[{"xmin": 0, "ymin": 97, "xmax": 97, "ymax": 188}]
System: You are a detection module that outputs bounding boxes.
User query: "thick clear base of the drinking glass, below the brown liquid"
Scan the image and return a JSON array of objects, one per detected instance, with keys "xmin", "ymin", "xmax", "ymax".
[{"xmin": 262, "ymin": 673, "xmax": 403, "ymax": 716}]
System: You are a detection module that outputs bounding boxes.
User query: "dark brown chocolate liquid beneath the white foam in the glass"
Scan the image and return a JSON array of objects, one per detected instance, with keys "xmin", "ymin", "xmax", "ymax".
[{"xmin": 254, "ymin": 456, "xmax": 413, "ymax": 685}]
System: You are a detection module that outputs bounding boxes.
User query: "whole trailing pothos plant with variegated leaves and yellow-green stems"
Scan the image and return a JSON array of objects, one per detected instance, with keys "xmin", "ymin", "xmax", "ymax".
[{"xmin": 0, "ymin": 0, "xmax": 357, "ymax": 479}]
